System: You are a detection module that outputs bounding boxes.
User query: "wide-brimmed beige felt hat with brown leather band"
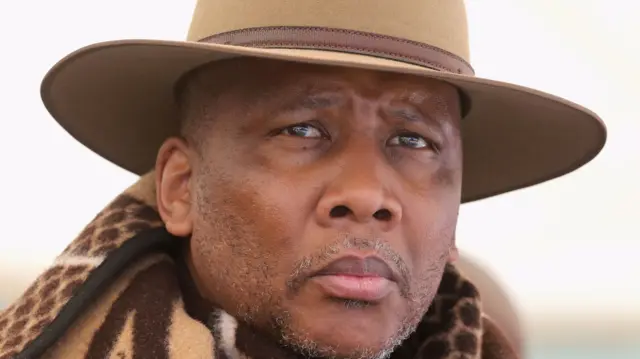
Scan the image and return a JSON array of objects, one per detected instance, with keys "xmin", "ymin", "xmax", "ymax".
[{"xmin": 42, "ymin": 0, "xmax": 606, "ymax": 202}]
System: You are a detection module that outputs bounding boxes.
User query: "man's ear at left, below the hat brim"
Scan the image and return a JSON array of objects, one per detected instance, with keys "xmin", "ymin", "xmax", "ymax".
[{"xmin": 155, "ymin": 137, "xmax": 193, "ymax": 237}]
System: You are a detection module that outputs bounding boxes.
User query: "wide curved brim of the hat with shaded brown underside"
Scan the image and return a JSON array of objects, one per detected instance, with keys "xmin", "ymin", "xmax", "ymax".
[{"xmin": 41, "ymin": 40, "xmax": 606, "ymax": 203}]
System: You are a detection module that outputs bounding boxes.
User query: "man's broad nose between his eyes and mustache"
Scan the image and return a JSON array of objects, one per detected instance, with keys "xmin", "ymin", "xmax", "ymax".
[{"xmin": 316, "ymin": 156, "xmax": 402, "ymax": 231}]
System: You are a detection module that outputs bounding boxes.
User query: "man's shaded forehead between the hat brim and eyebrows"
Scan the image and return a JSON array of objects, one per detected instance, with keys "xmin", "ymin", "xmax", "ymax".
[{"xmin": 182, "ymin": 58, "xmax": 456, "ymax": 104}]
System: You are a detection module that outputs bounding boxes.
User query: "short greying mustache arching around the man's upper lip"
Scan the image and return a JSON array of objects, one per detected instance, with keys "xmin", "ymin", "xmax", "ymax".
[{"xmin": 287, "ymin": 233, "xmax": 411, "ymax": 298}]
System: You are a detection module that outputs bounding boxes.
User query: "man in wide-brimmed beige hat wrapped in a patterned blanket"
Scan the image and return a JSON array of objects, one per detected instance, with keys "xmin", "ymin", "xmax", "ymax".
[{"xmin": 0, "ymin": 0, "xmax": 605, "ymax": 359}]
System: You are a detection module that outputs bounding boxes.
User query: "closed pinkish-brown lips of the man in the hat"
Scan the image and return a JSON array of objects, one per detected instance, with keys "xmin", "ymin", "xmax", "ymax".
[{"xmin": 311, "ymin": 256, "xmax": 396, "ymax": 302}]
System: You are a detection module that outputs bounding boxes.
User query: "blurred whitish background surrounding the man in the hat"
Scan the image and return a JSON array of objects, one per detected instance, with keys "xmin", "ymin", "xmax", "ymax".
[{"xmin": 0, "ymin": 0, "xmax": 640, "ymax": 359}]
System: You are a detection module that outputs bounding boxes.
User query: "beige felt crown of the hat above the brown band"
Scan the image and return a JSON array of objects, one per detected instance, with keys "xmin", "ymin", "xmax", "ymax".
[{"xmin": 187, "ymin": 0, "xmax": 469, "ymax": 62}]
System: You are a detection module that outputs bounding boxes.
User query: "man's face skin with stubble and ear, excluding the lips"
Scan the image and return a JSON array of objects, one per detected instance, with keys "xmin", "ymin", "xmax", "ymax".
[{"xmin": 156, "ymin": 59, "xmax": 462, "ymax": 358}]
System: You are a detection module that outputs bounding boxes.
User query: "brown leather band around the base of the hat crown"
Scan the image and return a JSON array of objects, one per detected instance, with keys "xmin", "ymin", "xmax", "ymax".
[{"xmin": 198, "ymin": 26, "xmax": 474, "ymax": 75}]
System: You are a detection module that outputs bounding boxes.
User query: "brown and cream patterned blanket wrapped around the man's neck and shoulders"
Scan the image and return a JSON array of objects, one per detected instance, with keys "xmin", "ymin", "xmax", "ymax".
[{"xmin": 0, "ymin": 173, "xmax": 516, "ymax": 359}]
